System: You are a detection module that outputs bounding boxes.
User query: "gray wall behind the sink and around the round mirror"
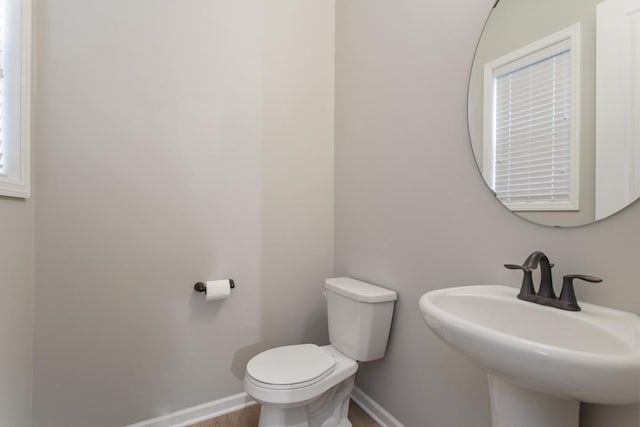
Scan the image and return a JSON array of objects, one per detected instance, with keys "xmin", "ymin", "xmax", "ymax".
[{"xmin": 335, "ymin": 0, "xmax": 640, "ymax": 427}]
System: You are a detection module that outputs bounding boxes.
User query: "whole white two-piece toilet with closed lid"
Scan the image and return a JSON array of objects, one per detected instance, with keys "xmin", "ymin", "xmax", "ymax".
[{"xmin": 244, "ymin": 277, "xmax": 397, "ymax": 427}]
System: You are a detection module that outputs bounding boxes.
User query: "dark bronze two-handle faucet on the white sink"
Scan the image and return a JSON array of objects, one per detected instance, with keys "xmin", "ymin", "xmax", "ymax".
[{"xmin": 504, "ymin": 251, "xmax": 602, "ymax": 311}]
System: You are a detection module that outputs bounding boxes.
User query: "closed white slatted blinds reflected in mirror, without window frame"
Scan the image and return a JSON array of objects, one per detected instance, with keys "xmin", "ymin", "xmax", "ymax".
[{"xmin": 493, "ymin": 50, "xmax": 571, "ymax": 203}]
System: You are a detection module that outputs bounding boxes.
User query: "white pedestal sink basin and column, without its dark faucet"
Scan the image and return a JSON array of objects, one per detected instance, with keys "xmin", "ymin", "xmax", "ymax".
[{"xmin": 419, "ymin": 285, "xmax": 640, "ymax": 427}]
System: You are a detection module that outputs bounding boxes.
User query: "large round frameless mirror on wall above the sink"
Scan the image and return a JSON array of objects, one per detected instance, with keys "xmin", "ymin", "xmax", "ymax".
[{"xmin": 468, "ymin": 0, "xmax": 640, "ymax": 226}]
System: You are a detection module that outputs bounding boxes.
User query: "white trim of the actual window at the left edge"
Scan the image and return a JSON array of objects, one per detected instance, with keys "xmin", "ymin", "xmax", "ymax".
[{"xmin": 0, "ymin": 0, "xmax": 32, "ymax": 199}]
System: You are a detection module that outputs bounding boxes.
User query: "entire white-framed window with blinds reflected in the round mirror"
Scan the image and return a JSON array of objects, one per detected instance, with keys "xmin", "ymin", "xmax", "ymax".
[{"xmin": 482, "ymin": 24, "xmax": 581, "ymax": 211}]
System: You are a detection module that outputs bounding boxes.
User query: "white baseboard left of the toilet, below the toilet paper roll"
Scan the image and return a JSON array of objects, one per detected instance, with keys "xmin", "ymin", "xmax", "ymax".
[{"xmin": 126, "ymin": 393, "xmax": 256, "ymax": 427}]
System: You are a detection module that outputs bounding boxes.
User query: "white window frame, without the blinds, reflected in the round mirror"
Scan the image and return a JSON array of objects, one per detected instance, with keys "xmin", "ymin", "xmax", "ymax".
[{"xmin": 482, "ymin": 23, "xmax": 582, "ymax": 211}]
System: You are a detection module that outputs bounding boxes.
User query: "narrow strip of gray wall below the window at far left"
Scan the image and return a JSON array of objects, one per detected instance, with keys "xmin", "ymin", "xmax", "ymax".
[{"xmin": 0, "ymin": 197, "xmax": 33, "ymax": 427}]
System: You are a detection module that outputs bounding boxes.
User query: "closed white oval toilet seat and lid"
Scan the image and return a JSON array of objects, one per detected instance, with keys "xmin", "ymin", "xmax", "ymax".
[{"xmin": 247, "ymin": 344, "xmax": 336, "ymax": 390}]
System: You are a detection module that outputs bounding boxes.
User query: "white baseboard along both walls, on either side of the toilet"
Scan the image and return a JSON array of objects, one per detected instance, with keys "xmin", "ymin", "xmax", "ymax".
[{"xmin": 125, "ymin": 387, "xmax": 404, "ymax": 427}]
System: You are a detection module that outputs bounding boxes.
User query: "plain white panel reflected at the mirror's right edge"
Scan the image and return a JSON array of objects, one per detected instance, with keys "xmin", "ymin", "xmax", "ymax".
[{"xmin": 595, "ymin": 0, "xmax": 640, "ymax": 220}]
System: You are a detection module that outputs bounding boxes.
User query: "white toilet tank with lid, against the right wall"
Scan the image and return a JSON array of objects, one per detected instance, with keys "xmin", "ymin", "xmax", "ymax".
[{"xmin": 325, "ymin": 277, "xmax": 398, "ymax": 362}]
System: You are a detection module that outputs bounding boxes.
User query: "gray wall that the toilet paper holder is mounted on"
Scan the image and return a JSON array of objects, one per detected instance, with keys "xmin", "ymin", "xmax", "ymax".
[{"xmin": 34, "ymin": 0, "xmax": 334, "ymax": 427}]
